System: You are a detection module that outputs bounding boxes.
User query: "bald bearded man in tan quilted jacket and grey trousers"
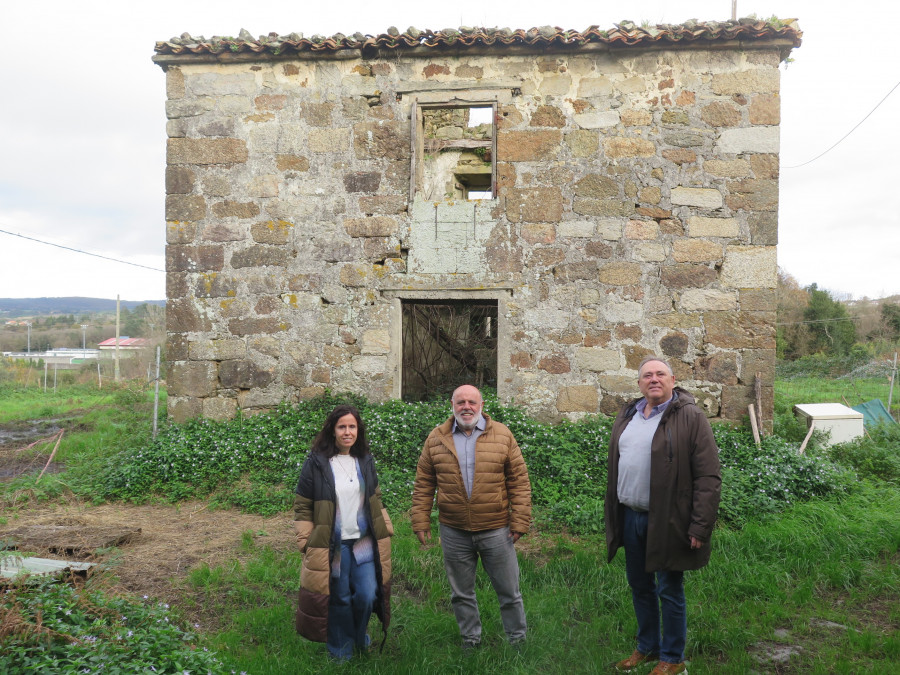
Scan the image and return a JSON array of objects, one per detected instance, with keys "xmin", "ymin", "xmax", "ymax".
[{"xmin": 412, "ymin": 385, "xmax": 531, "ymax": 649}]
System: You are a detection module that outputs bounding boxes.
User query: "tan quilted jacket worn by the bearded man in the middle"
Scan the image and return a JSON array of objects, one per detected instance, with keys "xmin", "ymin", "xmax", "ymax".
[{"xmin": 411, "ymin": 415, "xmax": 531, "ymax": 534}]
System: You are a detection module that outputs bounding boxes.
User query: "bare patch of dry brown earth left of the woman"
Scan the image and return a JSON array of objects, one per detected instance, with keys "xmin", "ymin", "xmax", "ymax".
[{"xmin": 0, "ymin": 502, "xmax": 299, "ymax": 605}]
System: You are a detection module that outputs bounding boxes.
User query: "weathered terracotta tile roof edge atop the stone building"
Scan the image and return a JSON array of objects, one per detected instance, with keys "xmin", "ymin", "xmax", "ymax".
[{"xmin": 155, "ymin": 18, "xmax": 803, "ymax": 56}]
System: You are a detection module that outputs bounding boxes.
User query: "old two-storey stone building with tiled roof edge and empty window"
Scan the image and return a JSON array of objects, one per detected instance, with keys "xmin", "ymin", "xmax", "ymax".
[{"xmin": 154, "ymin": 19, "xmax": 802, "ymax": 421}]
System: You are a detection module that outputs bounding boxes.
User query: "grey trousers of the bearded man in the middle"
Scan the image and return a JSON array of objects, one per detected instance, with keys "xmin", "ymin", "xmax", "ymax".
[{"xmin": 440, "ymin": 524, "xmax": 526, "ymax": 643}]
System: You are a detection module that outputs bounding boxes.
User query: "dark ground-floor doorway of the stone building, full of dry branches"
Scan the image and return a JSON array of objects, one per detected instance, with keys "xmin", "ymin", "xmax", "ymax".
[{"xmin": 401, "ymin": 300, "xmax": 497, "ymax": 401}]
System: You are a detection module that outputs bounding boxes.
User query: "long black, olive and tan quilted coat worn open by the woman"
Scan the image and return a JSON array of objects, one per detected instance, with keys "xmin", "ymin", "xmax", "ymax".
[{"xmin": 294, "ymin": 452, "xmax": 394, "ymax": 642}]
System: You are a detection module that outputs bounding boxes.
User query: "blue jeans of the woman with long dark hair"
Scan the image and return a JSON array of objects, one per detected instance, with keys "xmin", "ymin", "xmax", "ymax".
[{"xmin": 327, "ymin": 539, "xmax": 376, "ymax": 660}]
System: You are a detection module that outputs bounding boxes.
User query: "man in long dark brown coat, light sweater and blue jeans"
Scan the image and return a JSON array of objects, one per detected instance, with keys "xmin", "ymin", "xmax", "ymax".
[{"xmin": 605, "ymin": 357, "xmax": 722, "ymax": 675}]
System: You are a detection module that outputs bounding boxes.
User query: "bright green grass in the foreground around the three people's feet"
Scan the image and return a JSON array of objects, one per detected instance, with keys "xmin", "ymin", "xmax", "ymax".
[{"xmin": 171, "ymin": 488, "xmax": 900, "ymax": 675}]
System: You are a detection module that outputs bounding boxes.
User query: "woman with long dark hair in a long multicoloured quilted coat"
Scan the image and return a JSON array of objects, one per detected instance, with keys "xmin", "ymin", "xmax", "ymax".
[{"xmin": 294, "ymin": 405, "xmax": 394, "ymax": 660}]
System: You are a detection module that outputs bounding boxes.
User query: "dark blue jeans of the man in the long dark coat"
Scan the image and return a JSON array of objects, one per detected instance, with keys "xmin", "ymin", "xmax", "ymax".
[{"xmin": 622, "ymin": 504, "xmax": 687, "ymax": 663}]
